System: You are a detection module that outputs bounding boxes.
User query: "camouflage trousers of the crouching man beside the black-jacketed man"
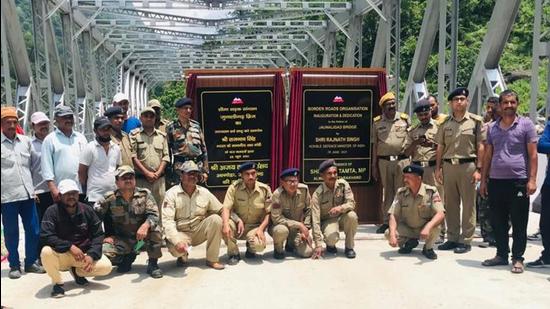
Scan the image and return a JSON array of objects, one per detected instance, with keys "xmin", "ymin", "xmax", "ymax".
[{"xmin": 103, "ymin": 231, "xmax": 162, "ymax": 265}]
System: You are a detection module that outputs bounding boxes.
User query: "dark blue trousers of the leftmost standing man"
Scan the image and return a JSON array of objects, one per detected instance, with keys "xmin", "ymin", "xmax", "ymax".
[{"xmin": 2, "ymin": 199, "xmax": 40, "ymax": 268}]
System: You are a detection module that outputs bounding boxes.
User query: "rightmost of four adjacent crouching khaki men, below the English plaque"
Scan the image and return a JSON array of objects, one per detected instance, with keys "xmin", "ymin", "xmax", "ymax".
[{"xmin": 311, "ymin": 160, "xmax": 358, "ymax": 259}]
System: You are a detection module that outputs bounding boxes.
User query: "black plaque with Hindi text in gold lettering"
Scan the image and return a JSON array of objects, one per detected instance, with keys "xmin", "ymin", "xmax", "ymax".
[{"xmin": 198, "ymin": 88, "xmax": 273, "ymax": 188}]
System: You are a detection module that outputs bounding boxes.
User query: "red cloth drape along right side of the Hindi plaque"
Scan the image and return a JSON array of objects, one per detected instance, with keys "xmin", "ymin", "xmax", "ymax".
[{"xmin": 270, "ymin": 73, "xmax": 285, "ymax": 190}]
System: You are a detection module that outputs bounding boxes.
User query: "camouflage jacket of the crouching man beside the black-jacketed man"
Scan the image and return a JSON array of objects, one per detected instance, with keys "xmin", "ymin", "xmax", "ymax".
[{"xmin": 94, "ymin": 187, "xmax": 159, "ymax": 238}]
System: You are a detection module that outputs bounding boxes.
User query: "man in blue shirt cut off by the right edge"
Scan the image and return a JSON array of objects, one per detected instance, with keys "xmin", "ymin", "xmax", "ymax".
[{"xmin": 527, "ymin": 118, "xmax": 550, "ymax": 267}]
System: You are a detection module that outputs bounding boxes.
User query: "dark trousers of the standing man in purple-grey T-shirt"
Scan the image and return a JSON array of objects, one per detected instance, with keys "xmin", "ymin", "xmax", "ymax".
[{"xmin": 488, "ymin": 179, "xmax": 529, "ymax": 261}]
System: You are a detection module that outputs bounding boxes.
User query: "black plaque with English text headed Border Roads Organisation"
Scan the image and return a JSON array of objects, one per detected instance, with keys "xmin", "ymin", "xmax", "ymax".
[{"xmin": 302, "ymin": 86, "xmax": 374, "ymax": 184}]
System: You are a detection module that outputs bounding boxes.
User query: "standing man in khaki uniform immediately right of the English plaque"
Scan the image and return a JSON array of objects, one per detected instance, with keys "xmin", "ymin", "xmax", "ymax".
[{"xmin": 371, "ymin": 92, "xmax": 409, "ymax": 234}]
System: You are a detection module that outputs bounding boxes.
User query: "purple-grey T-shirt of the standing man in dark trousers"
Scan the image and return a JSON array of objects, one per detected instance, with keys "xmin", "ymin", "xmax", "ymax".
[{"xmin": 487, "ymin": 116, "xmax": 537, "ymax": 179}]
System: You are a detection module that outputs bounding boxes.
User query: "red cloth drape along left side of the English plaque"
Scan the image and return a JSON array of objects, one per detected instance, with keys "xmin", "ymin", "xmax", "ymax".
[{"xmin": 287, "ymin": 71, "xmax": 304, "ymax": 168}]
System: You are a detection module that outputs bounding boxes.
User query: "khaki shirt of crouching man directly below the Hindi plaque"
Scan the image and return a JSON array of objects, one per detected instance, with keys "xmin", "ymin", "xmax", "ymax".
[{"xmin": 223, "ymin": 179, "xmax": 272, "ymax": 226}]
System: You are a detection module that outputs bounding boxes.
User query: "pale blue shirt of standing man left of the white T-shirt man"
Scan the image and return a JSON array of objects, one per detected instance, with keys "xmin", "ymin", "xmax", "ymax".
[{"xmin": 41, "ymin": 128, "xmax": 88, "ymax": 186}]
